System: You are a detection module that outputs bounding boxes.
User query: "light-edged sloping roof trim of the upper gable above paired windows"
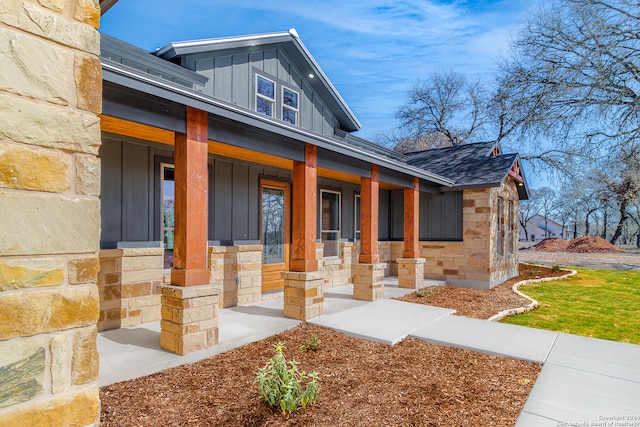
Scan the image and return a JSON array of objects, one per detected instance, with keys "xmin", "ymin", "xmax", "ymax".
[{"xmin": 155, "ymin": 29, "xmax": 362, "ymax": 132}]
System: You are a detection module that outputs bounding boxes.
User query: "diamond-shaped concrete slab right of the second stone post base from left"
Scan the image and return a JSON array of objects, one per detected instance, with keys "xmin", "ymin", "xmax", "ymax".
[{"xmin": 309, "ymin": 300, "xmax": 455, "ymax": 345}]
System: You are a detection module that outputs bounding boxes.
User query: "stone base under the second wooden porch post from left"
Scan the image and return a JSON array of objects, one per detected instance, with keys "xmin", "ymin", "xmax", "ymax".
[{"xmin": 282, "ymin": 271, "xmax": 324, "ymax": 320}]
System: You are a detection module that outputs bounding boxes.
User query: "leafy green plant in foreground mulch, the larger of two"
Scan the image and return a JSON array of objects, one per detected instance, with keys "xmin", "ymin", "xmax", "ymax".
[{"xmin": 255, "ymin": 342, "xmax": 320, "ymax": 414}]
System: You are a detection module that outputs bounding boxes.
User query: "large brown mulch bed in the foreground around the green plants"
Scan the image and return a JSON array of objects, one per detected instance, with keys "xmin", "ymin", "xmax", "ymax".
[{"xmin": 100, "ymin": 324, "xmax": 540, "ymax": 426}]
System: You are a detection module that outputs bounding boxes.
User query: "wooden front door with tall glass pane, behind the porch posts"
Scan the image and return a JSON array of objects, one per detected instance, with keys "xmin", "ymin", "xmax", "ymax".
[{"xmin": 260, "ymin": 180, "xmax": 290, "ymax": 293}]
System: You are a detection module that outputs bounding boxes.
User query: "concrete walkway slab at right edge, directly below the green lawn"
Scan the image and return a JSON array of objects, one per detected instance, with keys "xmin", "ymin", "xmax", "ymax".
[{"xmin": 547, "ymin": 334, "xmax": 640, "ymax": 382}]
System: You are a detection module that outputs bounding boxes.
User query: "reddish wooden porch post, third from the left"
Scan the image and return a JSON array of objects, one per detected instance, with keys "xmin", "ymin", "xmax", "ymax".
[{"xmin": 358, "ymin": 165, "xmax": 380, "ymax": 264}]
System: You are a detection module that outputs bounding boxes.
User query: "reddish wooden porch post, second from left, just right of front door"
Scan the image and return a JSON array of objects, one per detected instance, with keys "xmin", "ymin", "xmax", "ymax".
[{"xmin": 289, "ymin": 144, "xmax": 318, "ymax": 272}]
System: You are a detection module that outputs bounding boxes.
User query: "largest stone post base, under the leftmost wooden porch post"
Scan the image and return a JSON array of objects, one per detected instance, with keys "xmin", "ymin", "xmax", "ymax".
[{"xmin": 160, "ymin": 285, "xmax": 220, "ymax": 355}]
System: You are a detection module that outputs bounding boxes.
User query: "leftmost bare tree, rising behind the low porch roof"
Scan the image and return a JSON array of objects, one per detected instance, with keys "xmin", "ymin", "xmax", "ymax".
[{"xmin": 396, "ymin": 71, "xmax": 487, "ymax": 146}]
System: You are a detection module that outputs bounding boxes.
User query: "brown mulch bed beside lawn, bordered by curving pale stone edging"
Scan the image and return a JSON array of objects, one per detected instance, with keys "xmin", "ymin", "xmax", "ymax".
[{"xmin": 396, "ymin": 264, "xmax": 568, "ymax": 319}]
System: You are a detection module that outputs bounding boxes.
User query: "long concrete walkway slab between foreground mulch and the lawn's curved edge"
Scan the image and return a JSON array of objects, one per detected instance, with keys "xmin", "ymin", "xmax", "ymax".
[{"xmin": 411, "ymin": 316, "xmax": 558, "ymax": 363}]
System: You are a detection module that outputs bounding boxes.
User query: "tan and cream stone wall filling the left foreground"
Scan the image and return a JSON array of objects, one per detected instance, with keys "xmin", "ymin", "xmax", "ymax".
[{"xmin": 0, "ymin": 0, "xmax": 102, "ymax": 426}]
